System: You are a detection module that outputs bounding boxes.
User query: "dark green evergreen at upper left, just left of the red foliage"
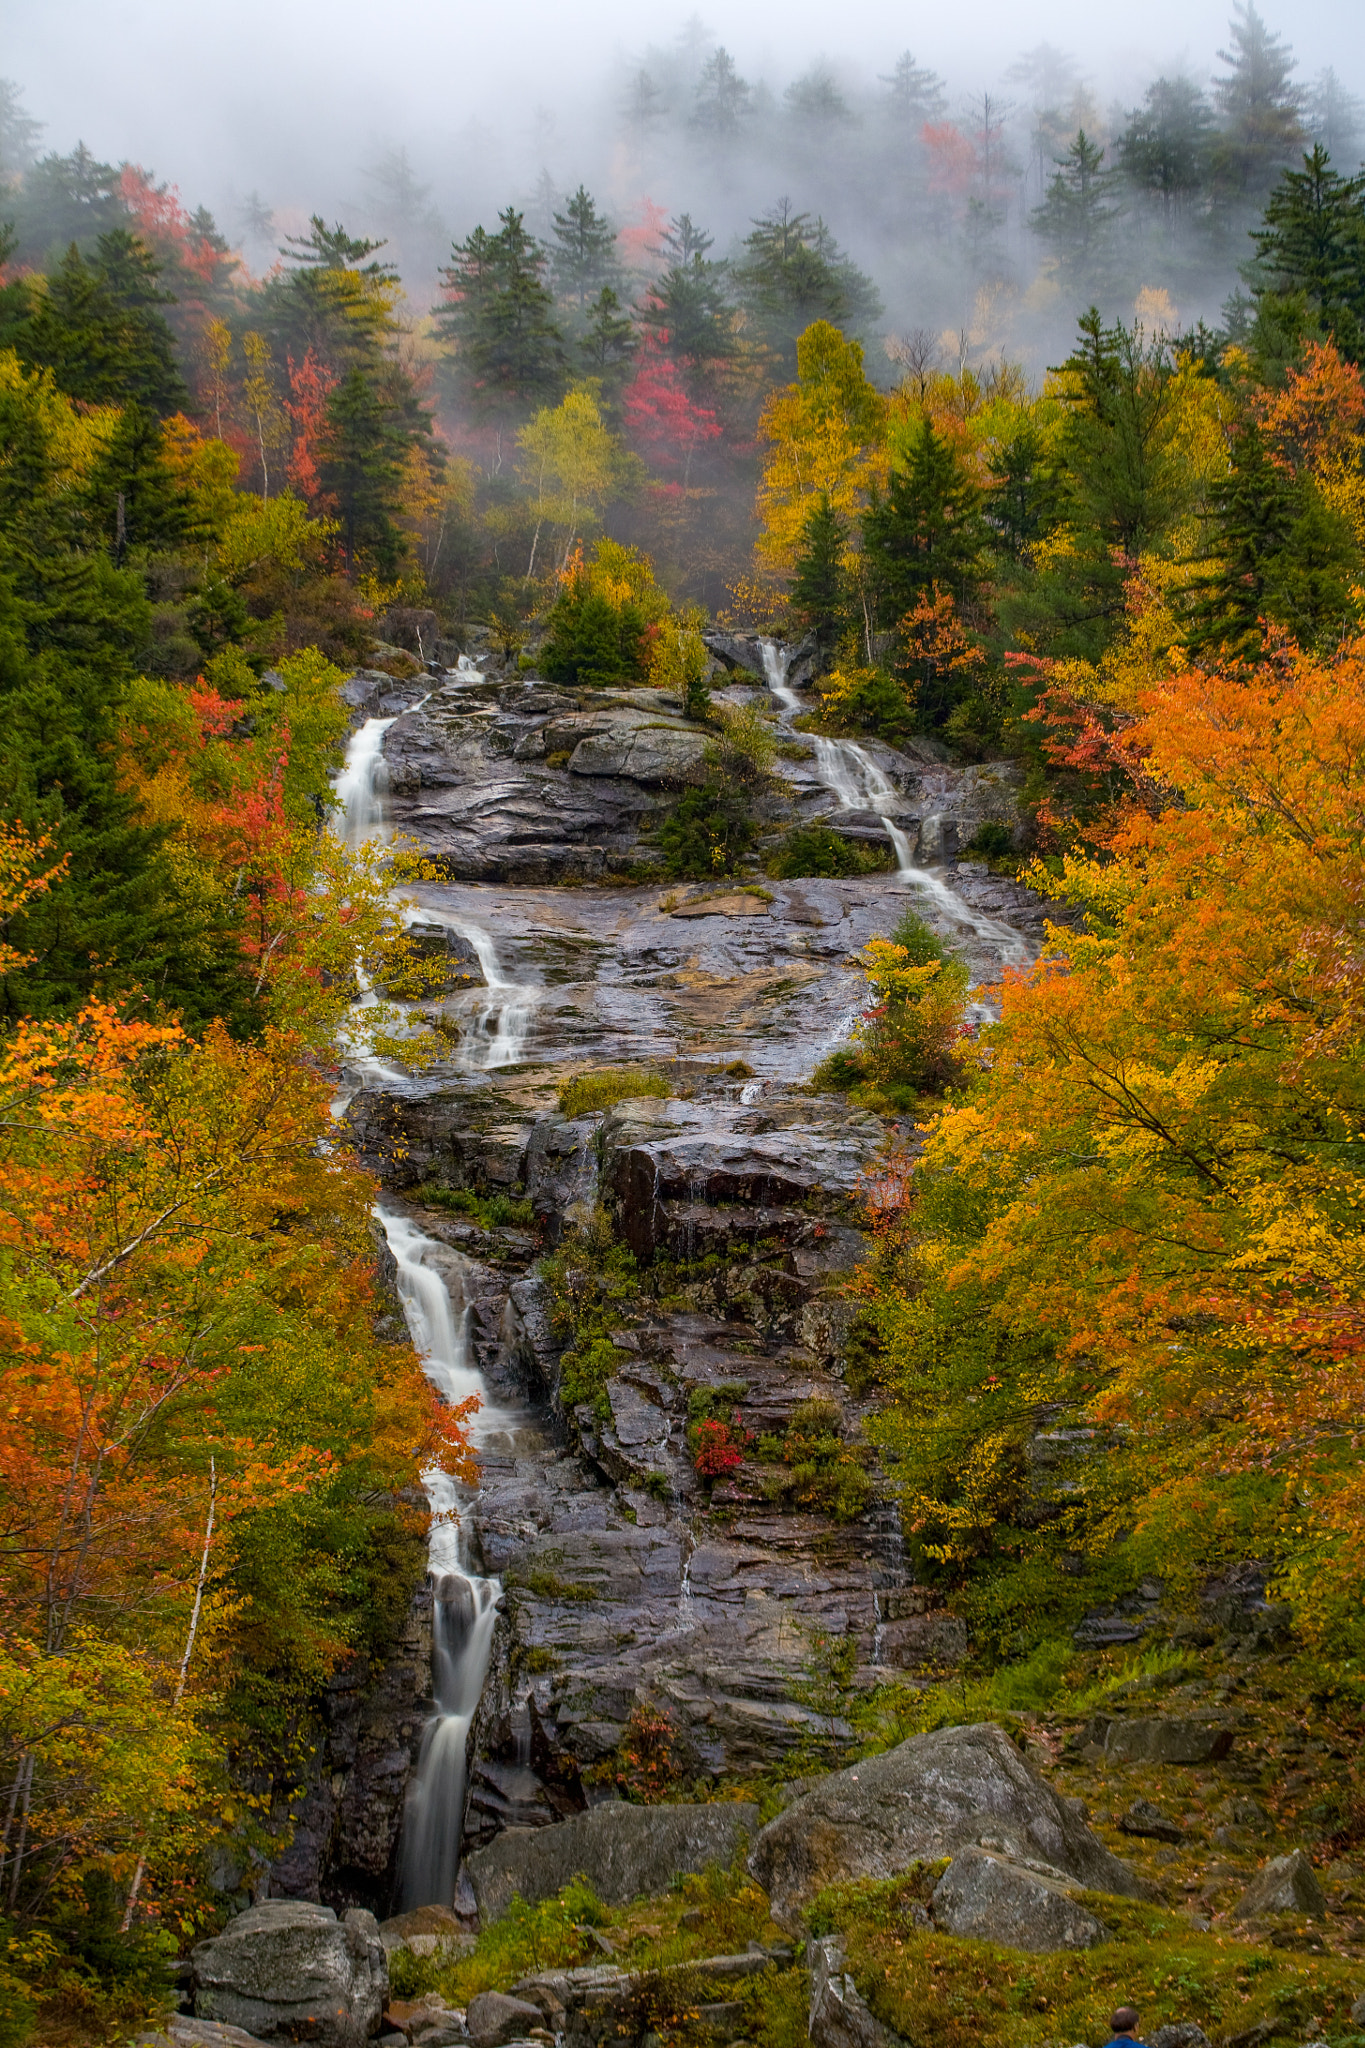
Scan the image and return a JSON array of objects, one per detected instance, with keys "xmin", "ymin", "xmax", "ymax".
[{"xmin": 14, "ymin": 227, "xmax": 188, "ymax": 416}]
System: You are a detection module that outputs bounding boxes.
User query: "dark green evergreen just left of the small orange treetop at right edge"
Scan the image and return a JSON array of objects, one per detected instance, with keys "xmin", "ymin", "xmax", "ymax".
[{"xmin": 1189, "ymin": 426, "xmax": 1361, "ymax": 657}]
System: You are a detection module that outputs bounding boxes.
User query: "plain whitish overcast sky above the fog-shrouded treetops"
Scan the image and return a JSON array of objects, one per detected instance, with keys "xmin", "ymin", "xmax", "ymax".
[{"xmin": 0, "ymin": 0, "xmax": 1365, "ymax": 243}]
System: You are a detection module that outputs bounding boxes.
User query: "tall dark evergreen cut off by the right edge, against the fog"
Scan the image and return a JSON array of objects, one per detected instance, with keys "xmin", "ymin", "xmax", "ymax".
[{"xmin": 1246, "ymin": 143, "xmax": 1365, "ymax": 360}]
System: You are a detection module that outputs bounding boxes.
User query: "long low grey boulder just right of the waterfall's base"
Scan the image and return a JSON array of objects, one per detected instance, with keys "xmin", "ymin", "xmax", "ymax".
[{"xmin": 465, "ymin": 1800, "xmax": 759, "ymax": 1927}]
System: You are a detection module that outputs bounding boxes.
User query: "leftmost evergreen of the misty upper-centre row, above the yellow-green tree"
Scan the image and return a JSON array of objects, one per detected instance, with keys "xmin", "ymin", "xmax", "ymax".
[{"xmin": 438, "ymin": 207, "xmax": 565, "ymax": 416}]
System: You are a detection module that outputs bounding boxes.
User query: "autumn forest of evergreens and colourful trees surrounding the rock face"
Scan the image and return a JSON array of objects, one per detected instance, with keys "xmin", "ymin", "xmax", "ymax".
[{"xmin": 0, "ymin": 0, "xmax": 1365, "ymax": 2048}]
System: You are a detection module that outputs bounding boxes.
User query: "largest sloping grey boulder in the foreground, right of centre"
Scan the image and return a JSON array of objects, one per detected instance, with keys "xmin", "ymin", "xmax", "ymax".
[{"xmin": 749, "ymin": 1722, "xmax": 1146, "ymax": 1925}]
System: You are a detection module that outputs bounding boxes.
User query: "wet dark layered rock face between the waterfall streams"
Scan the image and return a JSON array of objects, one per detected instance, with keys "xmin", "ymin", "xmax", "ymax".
[{"xmin": 290, "ymin": 675, "xmax": 1048, "ymax": 1911}]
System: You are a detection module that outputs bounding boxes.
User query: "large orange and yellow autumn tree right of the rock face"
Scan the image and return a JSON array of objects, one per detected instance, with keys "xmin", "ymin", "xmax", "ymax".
[{"xmin": 864, "ymin": 639, "xmax": 1365, "ymax": 1651}]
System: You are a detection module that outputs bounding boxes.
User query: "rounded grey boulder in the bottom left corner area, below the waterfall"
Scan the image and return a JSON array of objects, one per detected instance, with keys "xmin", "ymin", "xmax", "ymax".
[{"xmin": 190, "ymin": 1898, "xmax": 389, "ymax": 2048}]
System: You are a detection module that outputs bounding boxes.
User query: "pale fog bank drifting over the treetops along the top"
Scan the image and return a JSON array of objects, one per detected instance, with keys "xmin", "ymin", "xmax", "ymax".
[{"xmin": 0, "ymin": 0, "xmax": 1365, "ymax": 360}]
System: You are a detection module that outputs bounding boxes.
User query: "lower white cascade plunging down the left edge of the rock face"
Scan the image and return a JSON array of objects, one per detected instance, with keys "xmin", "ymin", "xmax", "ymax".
[{"xmin": 377, "ymin": 1208, "xmax": 501, "ymax": 1911}]
